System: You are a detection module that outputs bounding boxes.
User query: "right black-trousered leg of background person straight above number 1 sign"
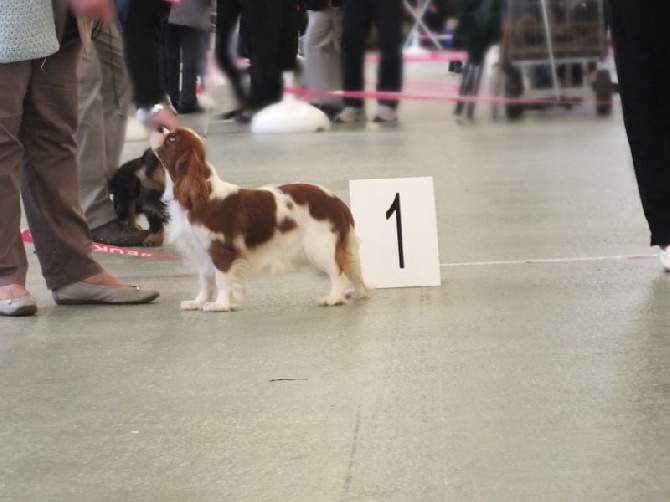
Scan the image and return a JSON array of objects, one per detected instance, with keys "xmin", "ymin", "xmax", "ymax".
[{"xmin": 374, "ymin": 0, "xmax": 403, "ymax": 117}]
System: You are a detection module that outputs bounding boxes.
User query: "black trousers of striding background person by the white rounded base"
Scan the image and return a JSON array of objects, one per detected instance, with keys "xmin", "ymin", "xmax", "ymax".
[{"xmin": 216, "ymin": 0, "xmax": 298, "ymax": 109}]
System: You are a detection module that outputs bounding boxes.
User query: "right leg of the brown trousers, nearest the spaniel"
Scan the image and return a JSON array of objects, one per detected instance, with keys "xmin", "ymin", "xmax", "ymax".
[{"xmin": 19, "ymin": 37, "xmax": 102, "ymax": 289}]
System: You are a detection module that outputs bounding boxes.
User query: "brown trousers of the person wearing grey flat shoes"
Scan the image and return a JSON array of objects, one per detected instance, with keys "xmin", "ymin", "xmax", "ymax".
[{"xmin": 0, "ymin": 5, "xmax": 101, "ymax": 289}]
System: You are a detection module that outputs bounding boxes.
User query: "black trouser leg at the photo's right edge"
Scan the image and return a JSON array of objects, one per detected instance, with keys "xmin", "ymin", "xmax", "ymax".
[{"xmin": 609, "ymin": 0, "xmax": 670, "ymax": 246}]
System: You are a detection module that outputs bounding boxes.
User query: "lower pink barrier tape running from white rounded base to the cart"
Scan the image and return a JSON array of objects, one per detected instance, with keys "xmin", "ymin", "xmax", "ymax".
[{"xmin": 284, "ymin": 87, "xmax": 611, "ymax": 106}]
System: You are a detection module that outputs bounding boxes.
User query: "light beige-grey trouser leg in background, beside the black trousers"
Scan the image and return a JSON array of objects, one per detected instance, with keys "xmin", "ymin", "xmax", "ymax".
[{"xmin": 305, "ymin": 7, "xmax": 342, "ymax": 106}]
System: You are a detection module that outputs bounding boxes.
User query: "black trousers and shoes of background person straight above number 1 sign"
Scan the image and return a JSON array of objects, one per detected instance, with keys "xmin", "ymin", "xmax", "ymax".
[{"xmin": 342, "ymin": 0, "xmax": 403, "ymax": 107}]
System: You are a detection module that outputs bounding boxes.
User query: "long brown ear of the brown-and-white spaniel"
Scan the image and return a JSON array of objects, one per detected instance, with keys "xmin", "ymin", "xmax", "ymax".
[{"xmin": 174, "ymin": 149, "xmax": 211, "ymax": 209}]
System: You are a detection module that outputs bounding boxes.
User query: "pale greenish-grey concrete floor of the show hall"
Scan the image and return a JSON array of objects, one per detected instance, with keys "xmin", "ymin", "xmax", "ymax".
[{"xmin": 0, "ymin": 66, "xmax": 670, "ymax": 502}]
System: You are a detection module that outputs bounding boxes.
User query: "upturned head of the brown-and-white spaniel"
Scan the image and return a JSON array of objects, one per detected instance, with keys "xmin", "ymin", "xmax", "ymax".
[{"xmin": 149, "ymin": 128, "xmax": 211, "ymax": 209}]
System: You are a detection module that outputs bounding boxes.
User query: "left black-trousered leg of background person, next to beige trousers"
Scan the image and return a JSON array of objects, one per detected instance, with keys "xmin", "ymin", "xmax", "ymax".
[{"xmin": 342, "ymin": 0, "xmax": 373, "ymax": 113}]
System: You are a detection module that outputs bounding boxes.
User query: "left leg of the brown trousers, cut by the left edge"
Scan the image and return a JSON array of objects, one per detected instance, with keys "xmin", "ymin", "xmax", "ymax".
[{"xmin": 0, "ymin": 61, "xmax": 31, "ymax": 300}]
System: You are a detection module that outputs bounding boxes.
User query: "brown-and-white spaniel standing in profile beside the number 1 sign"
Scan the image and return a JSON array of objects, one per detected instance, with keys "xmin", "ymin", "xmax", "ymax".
[{"xmin": 151, "ymin": 129, "xmax": 369, "ymax": 312}]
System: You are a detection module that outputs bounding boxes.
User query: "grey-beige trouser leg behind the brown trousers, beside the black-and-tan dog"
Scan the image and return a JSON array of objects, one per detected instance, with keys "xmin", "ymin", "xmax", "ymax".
[{"xmin": 76, "ymin": 24, "xmax": 131, "ymax": 228}]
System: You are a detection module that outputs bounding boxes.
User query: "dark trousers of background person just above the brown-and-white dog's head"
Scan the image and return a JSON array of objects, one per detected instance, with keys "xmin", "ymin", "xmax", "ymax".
[{"xmin": 164, "ymin": 23, "xmax": 203, "ymax": 108}]
